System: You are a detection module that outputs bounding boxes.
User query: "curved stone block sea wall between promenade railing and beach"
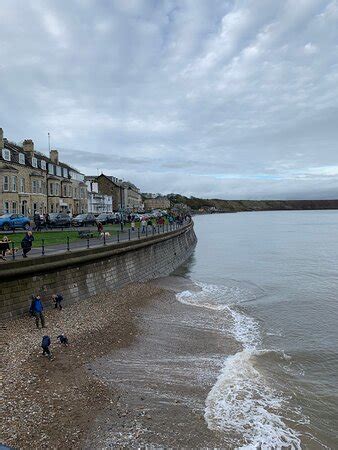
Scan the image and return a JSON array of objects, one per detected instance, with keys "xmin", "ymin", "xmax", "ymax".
[{"xmin": 0, "ymin": 223, "xmax": 197, "ymax": 319}]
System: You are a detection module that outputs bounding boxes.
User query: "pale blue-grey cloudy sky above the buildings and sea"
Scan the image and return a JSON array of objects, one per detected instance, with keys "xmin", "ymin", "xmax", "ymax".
[{"xmin": 0, "ymin": 0, "xmax": 338, "ymax": 199}]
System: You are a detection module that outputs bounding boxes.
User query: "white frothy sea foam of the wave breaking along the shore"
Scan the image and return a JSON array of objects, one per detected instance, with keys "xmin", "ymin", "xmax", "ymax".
[{"xmin": 177, "ymin": 282, "xmax": 301, "ymax": 449}]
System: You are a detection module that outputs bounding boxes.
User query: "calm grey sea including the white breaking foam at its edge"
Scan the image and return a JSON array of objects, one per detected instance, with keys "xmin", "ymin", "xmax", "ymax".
[{"xmin": 176, "ymin": 210, "xmax": 338, "ymax": 449}]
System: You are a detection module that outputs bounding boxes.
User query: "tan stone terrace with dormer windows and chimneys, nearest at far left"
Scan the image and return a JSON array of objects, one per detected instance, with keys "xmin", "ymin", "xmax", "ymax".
[{"xmin": 0, "ymin": 128, "xmax": 87, "ymax": 216}]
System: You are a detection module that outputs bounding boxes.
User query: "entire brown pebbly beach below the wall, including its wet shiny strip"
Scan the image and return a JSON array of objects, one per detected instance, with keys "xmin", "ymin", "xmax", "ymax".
[{"xmin": 1, "ymin": 278, "xmax": 236, "ymax": 449}]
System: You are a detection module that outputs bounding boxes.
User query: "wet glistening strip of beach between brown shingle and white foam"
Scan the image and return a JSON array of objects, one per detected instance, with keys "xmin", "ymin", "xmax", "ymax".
[{"xmin": 85, "ymin": 277, "xmax": 236, "ymax": 449}]
